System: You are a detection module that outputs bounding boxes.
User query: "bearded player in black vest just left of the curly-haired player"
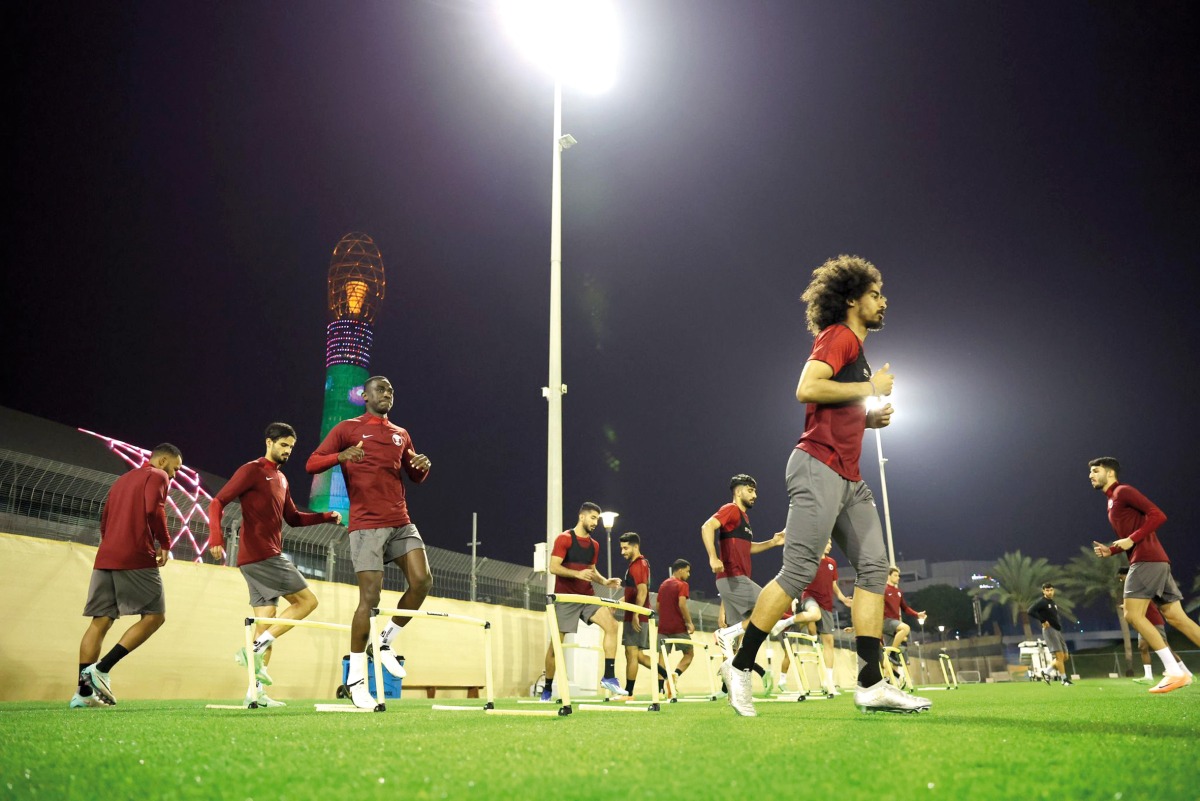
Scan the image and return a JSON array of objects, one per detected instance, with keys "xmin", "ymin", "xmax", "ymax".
[{"xmin": 700, "ymin": 472, "xmax": 784, "ymax": 661}]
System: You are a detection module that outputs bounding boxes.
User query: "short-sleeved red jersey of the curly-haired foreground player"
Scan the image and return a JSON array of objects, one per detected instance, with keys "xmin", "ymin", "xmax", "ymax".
[{"xmin": 796, "ymin": 323, "xmax": 871, "ymax": 481}]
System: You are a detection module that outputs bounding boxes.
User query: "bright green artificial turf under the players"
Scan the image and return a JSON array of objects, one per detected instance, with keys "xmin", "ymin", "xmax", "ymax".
[{"xmin": 0, "ymin": 679, "xmax": 1200, "ymax": 801}]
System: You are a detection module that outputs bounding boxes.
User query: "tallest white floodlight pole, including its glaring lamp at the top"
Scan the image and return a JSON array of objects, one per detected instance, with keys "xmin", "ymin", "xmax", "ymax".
[{"xmin": 500, "ymin": 0, "xmax": 617, "ymax": 592}]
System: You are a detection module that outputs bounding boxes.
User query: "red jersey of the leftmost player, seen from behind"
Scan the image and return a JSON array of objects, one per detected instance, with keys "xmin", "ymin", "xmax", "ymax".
[{"xmin": 96, "ymin": 462, "xmax": 170, "ymax": 570}]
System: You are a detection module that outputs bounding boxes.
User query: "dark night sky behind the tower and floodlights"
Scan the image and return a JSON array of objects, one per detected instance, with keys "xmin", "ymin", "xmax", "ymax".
[{"xmin": 0, "ymin": 0, "xmax": 1200, "ymax": 599}]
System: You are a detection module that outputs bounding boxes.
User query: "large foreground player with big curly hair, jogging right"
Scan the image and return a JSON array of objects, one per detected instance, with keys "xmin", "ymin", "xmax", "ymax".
[{"xmin": 721, "ymin": 255, "xmax": 930, "ymax": 716}]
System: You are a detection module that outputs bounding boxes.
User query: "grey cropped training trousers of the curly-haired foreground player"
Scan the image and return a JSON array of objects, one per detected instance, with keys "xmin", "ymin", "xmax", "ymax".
[{"xmin": 775, "ymin": 448, "xmax": 888, "ymax": 598}]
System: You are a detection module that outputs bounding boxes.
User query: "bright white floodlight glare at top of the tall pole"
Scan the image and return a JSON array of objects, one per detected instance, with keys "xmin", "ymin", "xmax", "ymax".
[{"xmin": 498, "ymin": 0, "xmax": 618, "ymax": 92}]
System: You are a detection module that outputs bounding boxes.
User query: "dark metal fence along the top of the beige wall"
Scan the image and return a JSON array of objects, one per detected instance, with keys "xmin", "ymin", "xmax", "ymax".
[{"xmin": 0, "ymin": 448, "xmax": 716, "ymax": 631}]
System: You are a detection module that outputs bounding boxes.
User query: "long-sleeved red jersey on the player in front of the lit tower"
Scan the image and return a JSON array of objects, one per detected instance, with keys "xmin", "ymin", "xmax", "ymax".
[{"xmin": 305, "ymin": 414, "xmax": 430, "ymax": 531}]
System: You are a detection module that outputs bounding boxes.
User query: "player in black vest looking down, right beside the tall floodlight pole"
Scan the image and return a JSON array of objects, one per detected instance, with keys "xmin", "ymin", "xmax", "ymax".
[{"xmin": 541, "ymin": 501, "xmax": 629, "ymax": 701}]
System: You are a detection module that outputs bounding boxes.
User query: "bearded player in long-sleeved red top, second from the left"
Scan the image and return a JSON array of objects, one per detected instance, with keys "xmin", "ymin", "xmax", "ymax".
[{"xmin": 209, "ymin": 423, "xmax": 342, "ymax": 706}]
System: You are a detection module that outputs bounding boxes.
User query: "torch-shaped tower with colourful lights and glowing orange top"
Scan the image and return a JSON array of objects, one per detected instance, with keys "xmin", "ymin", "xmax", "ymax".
[{"xmin": 308, "ymin": 233, "xmax": 388, "ymax": 520}]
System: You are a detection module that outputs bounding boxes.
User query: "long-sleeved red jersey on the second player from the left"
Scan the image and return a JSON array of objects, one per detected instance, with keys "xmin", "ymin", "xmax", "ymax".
[{"xmin": 209, "ymin": 457, "xmax": 334, "ymax": 565}]
